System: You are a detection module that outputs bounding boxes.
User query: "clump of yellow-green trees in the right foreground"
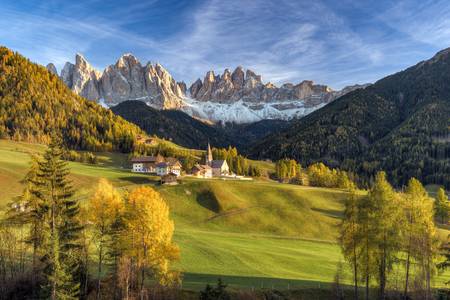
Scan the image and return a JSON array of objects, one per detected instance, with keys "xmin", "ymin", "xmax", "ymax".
[{"xmin": 339, "ymin": 172, "xmax": 450, "ymax": 299}]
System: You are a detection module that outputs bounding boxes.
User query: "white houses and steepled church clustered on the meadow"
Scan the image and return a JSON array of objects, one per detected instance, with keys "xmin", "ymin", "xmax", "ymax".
[{"xmin": 131, "ymin": 144, "xmax": 231, "ymax": 184}]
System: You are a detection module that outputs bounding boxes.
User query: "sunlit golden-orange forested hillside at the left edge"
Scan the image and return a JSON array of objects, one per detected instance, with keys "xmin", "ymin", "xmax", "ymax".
[{"xmin": 0, "ymin": 47, "xmax": 141, "ymax": 152}]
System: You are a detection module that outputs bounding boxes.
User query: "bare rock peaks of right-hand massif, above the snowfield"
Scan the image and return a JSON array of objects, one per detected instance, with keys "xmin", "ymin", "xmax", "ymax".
[{"xmin": 189, "ymin": 66, "xmax": 364, "ymax": 106}]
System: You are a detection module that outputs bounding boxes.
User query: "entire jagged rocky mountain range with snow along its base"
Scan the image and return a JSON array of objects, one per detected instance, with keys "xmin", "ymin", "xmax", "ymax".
[{"xmin": 47, "ymin": 54, "xmax": 367, "ymax": 124}]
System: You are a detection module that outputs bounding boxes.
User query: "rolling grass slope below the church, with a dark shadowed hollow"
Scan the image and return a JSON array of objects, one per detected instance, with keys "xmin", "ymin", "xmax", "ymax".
[{"xmin": 160, "ymin": 180, "xmax": 345, "ymax": 240}]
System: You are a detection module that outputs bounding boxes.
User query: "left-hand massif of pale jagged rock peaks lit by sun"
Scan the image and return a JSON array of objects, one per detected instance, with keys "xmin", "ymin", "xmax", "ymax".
[{"xmin": 55, "ymin": 54, "xmax": 186, "ymax": 109}]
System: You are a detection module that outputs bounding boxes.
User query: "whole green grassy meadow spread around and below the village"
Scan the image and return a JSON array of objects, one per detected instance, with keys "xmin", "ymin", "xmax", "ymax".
[{"xmin": 0, "ymin": 140, "xmax": 450, "ymax": 289}]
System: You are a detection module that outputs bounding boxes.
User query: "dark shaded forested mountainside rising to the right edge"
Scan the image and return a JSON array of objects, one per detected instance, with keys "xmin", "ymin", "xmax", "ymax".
[{"xmin": 249, "ymin": 49, "xmax": 450, "ymax": 187}]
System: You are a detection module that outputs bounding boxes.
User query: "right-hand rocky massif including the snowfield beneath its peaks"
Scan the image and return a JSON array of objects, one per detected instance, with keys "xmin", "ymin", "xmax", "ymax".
[{"xmin": 182, "ymin": 67, "xmax": 367, "ymax": 123}]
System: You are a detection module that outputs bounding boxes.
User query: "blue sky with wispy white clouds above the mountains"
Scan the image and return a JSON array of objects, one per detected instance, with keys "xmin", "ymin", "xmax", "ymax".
[{"xmin": 0, "ymin": 0, "xmax": 450, "ymax": 88}]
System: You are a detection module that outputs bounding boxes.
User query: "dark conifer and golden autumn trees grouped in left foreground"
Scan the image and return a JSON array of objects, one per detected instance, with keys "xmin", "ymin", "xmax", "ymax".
[{"xmin": 0, "ymin": 139, "xmax": 180, "ymax": 299}]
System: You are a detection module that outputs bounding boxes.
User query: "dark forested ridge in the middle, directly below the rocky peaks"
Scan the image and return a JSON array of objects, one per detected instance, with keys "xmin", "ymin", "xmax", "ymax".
[{"xmin": 111, "ymin": 100, "xmax": 288, "ymax": 149}]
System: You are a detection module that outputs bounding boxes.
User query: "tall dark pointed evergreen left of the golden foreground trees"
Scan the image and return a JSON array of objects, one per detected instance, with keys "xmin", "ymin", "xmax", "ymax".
[{"xmin": 31, "ymin": 138, "xmax": 81, "ymax": 299}]
